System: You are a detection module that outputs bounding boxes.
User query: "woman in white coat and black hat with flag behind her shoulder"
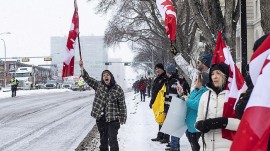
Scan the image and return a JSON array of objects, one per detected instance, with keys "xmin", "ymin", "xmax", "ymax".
[{"xmin": 195, "ymin": 32, "xmax": 244, "ymax": 150}]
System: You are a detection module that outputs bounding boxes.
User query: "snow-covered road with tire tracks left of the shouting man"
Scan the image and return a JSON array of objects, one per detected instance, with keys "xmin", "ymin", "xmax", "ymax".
[{"xmin": 0, "ymin": 91, "xmax": 95, "ymax": 151}]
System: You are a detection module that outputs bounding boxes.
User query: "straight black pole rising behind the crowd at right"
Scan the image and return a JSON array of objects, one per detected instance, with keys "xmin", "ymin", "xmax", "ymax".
[{"xmin": 240, "ymin": 0, "xmax": 247, "ymax": 77}]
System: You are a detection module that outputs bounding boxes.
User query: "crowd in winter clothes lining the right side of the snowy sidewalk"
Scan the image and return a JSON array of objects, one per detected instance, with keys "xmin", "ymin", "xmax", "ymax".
[{"xmin": 149, "ymin": 35, "xmax": 270, "ymax": 151}]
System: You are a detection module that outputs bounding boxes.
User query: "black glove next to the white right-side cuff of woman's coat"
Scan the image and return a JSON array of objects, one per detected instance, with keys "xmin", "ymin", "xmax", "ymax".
[{"xmin": 204, "ymin": 117, "xmax": 228, "ymax": 130}]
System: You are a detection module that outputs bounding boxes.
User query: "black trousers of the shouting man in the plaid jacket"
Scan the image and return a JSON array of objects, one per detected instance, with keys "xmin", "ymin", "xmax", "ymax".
[{"xmin": 96, "ymin": 118, "xmax": 120, "ymax": 151}]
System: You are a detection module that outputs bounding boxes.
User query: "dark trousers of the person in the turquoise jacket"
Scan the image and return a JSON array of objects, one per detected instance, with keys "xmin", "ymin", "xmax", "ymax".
[{"xmin": 186, "ymin": 130, "xmax": 201, "ymax": 151}]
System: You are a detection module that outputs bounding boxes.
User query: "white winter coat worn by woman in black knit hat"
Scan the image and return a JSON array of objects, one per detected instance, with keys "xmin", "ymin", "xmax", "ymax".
[{"xmin": 196, "ymin": 89, "xmax": 240, "ymax": 151}]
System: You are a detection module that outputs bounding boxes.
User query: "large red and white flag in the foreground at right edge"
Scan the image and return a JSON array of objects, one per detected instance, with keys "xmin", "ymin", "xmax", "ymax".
[{"xmin": 231, "ymin": 36, "xmax": 270, "ymax": 151}]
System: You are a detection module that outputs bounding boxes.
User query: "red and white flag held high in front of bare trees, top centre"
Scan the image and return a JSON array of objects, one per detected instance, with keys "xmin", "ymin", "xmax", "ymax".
[{"xmin": 156, "ymin": 0, "xmax": 176, "ymax": 41}]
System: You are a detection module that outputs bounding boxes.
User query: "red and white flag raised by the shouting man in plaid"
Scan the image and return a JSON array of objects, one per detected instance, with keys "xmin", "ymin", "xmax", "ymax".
[{"xmin": 62, "ymin": 0, "xmax": 79, "ymax": 78}]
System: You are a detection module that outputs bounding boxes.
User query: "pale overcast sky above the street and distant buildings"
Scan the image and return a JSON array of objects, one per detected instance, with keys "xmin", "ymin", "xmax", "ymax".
[{"xmin": 0, "ymin": 0, "xmax": 132, "ymax": 64}]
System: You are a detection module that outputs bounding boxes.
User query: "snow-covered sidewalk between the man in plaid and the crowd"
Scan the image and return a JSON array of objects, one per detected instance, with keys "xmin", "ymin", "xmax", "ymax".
[{"xmin": 118, "ymin": 92, "xmax": 191, "ymax": 151}]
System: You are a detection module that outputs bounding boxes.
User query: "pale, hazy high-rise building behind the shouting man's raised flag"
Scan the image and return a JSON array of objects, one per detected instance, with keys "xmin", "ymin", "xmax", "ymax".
[{"xmin": 51, "ymin": 36, "xmax": 108, "ymax": 80}]
